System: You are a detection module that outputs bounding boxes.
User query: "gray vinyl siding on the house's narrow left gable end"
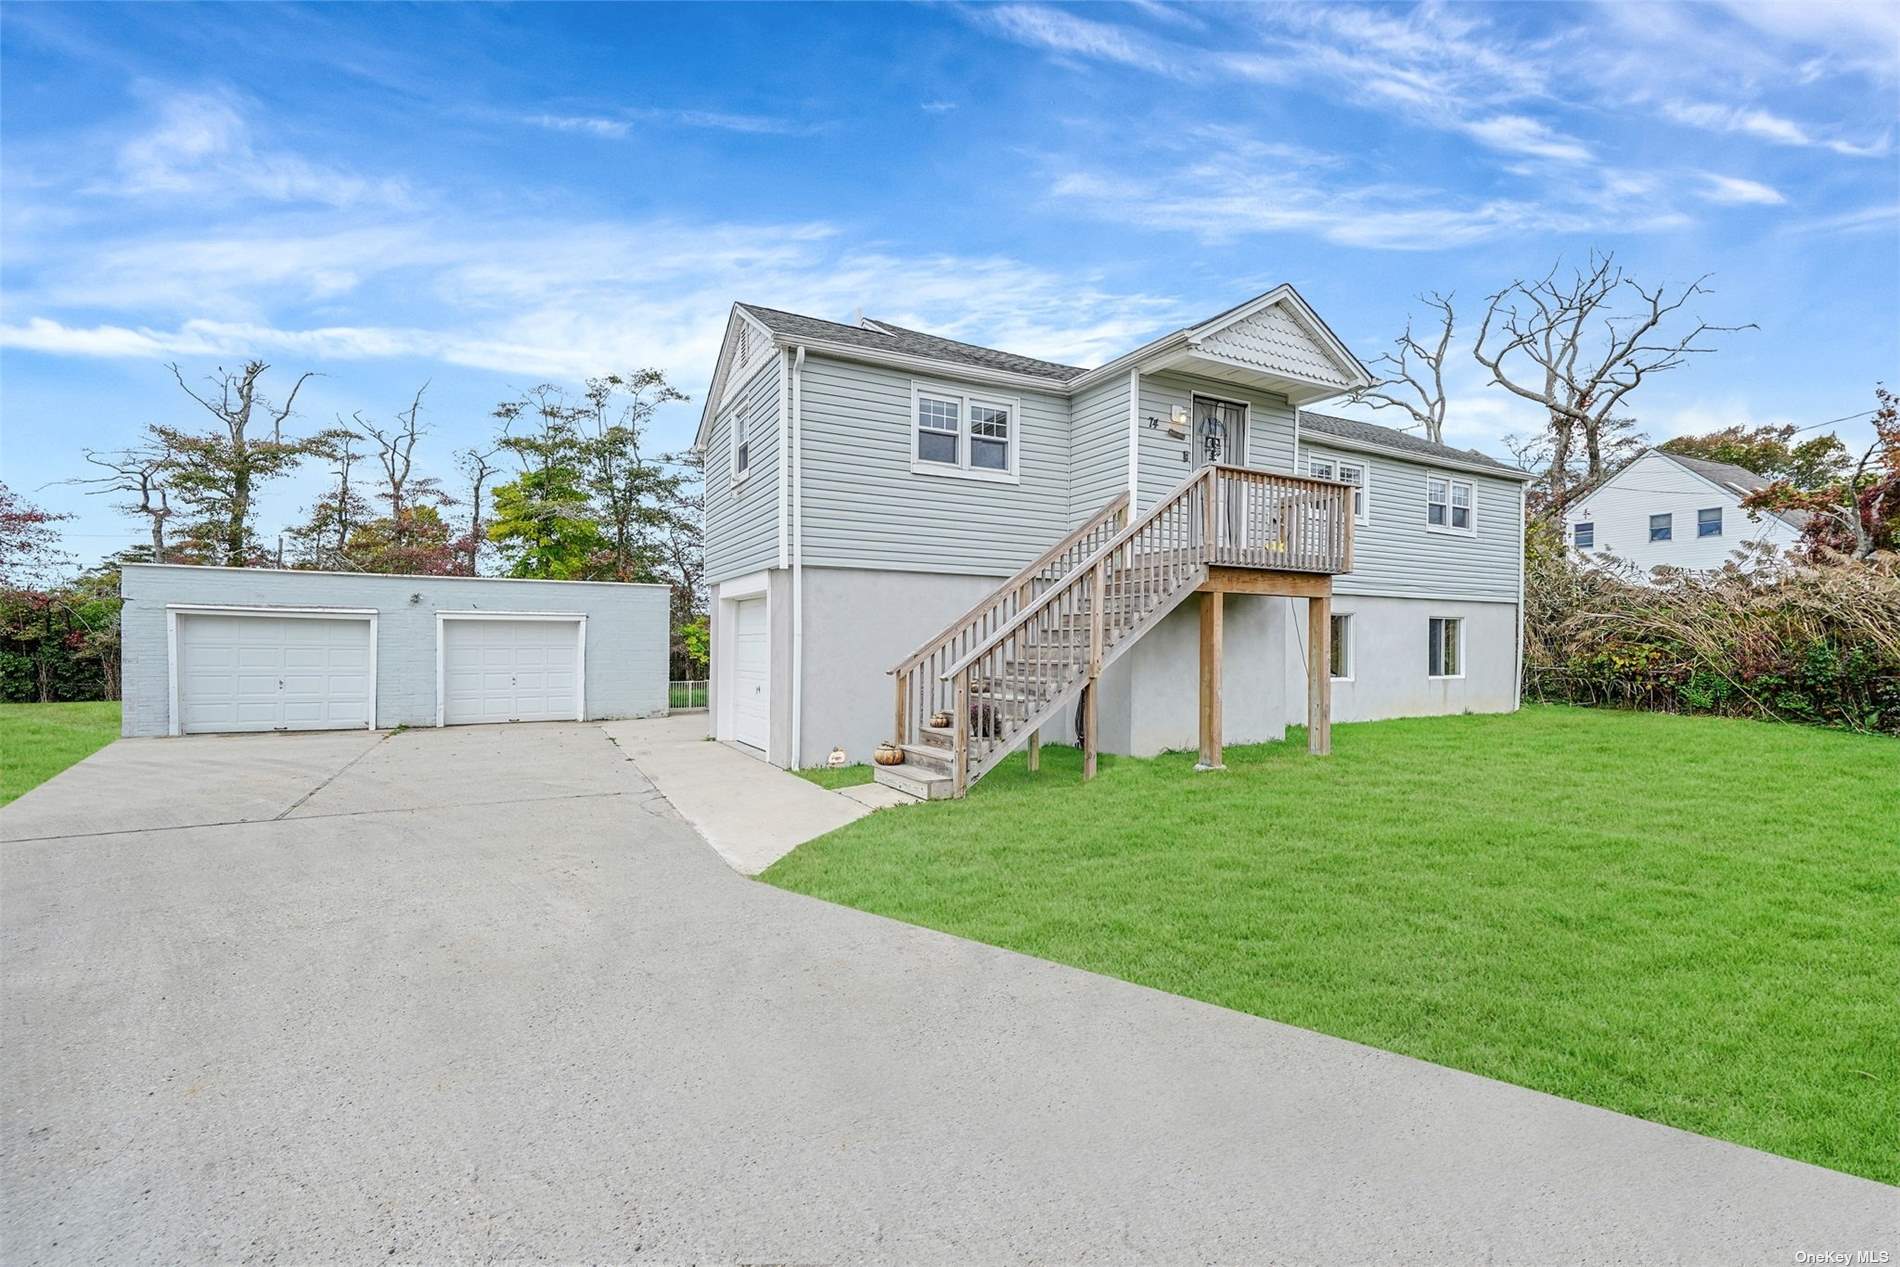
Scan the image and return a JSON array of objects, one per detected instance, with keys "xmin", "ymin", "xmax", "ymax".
[{"xmin": 705, "ymin": 357, "xmax": 781, "ymax": 583}]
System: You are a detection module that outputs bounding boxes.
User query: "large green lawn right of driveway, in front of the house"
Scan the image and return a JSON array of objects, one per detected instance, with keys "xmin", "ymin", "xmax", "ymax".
[{"xmin": 764, "ymin": 707, "xmax": 1900, "ymax": 1183}]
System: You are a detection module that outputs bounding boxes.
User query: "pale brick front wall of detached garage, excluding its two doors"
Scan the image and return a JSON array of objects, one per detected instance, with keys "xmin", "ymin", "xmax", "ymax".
[{"xmin": 120, "ymin": 564, "xmax": 669, "ymax": 735}]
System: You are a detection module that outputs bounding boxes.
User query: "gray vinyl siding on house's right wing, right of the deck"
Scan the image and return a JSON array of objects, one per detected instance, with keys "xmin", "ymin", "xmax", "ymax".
[{"xmin": 1300, "ymin": 440, "xmax": 1524, "ymax": 602}]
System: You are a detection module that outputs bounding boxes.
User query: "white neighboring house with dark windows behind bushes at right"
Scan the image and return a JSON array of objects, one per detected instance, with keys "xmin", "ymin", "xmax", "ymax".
[{"xmin": 1564, "ymin": 448, "xmax": 1805, "ymax": 574}]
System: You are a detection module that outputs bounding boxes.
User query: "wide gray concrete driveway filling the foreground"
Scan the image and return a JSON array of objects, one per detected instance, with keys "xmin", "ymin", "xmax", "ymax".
[{"xmin": 0, "ymin": 726, "xmax": 1900, "ymax": 1263}]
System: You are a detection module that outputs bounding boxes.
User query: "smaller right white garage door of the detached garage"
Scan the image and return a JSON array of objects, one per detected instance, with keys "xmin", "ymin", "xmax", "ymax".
[{"xmin": 443, "ymin": 619, "xmax": 581, "ymax": 726}]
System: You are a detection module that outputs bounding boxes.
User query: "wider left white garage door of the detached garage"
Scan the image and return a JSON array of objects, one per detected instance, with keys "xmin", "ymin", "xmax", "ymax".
[{"xmin": 177, "ymin": 612, "xmax": 371, "ymax": 735}]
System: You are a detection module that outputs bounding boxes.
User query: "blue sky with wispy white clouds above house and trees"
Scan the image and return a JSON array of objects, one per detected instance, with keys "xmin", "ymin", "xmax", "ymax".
[{"xmin": 0, "ymin": 2, "xmax": 1900, "ymax": 562}]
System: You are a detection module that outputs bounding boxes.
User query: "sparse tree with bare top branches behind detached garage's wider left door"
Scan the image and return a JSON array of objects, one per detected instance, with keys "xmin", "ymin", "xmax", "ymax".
[{"xmin": 148, "ymin": 361, "xmax": 314, "ymax": 568}]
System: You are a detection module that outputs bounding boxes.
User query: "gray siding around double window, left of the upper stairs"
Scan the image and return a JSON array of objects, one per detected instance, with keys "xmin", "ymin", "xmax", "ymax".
[{"xmin": 800, "ymin": 357, "xmax": 1070, "ymax": 576}]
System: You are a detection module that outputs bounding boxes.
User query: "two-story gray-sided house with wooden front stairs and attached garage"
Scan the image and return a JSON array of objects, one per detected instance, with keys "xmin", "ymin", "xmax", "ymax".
[{"xmin": 695, "ymin": 285, "xmax": 1528, "ymax": 794}]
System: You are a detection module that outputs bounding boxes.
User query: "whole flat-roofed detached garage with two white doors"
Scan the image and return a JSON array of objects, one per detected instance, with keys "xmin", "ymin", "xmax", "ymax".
[{"xmin": 120, "ymin": 564, "xmax": 669, "ymax": 735}]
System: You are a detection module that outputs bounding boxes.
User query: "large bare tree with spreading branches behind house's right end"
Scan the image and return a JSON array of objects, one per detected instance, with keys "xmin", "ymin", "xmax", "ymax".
[{"xmin": 1473, "ymin": 251, "xmax": 1754, "ymax": 513}]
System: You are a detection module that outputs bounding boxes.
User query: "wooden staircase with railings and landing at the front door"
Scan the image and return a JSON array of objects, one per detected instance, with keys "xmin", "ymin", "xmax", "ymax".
[{"xmin": 876, "ymin": 465, "xmax": 1353, "ymax": 800}]
